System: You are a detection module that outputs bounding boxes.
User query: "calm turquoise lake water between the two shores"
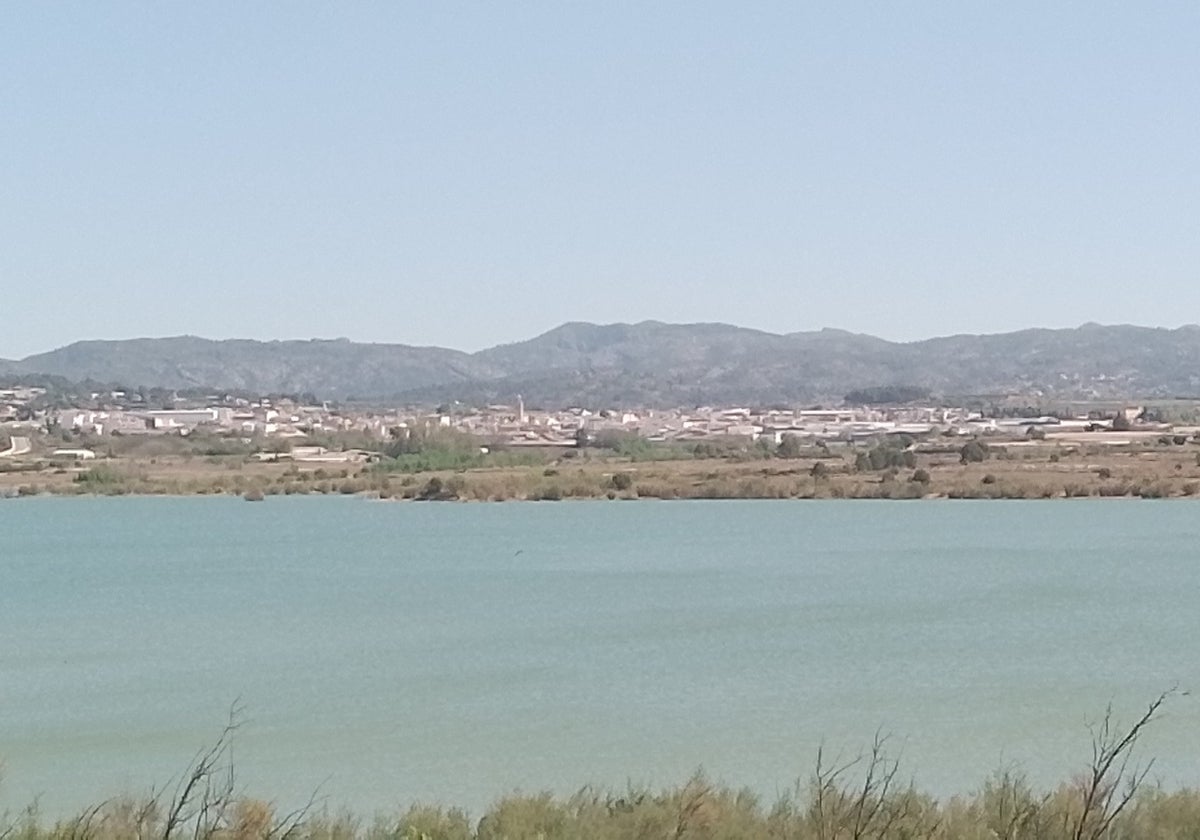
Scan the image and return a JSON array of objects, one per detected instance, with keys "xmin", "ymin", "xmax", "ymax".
[{"xmin": 0, "ymin": 498, "xmax": 1200, "ymax": 814}]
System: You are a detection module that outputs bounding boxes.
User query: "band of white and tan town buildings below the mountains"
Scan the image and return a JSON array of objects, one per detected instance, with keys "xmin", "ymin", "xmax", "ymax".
[{"xmin": 0, "ymin": 386, "xmax": 1180, "ymax": 460}]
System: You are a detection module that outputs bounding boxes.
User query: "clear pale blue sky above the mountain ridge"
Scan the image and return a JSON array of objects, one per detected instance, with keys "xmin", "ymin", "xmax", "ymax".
[{"xmin": 0, "ymin": 0, "xmax": 1200, "ymax": 358}]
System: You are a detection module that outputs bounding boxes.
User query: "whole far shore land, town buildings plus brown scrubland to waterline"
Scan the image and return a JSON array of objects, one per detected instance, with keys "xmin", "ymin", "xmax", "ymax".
[{"xmin": 7, "ymin": 385, "xmax": 1200, "ymax": 500}]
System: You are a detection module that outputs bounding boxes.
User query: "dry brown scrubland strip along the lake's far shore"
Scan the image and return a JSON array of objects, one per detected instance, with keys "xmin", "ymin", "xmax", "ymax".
[{"xmin": 0, "ymin": 434, "xmax": 1200, "ymax": 502}]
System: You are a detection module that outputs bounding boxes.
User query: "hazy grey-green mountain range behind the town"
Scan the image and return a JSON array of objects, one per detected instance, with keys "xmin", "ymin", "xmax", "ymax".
[{"xmin": 0, "ymin": 322, "xmax": 1200, "ymax": 407}]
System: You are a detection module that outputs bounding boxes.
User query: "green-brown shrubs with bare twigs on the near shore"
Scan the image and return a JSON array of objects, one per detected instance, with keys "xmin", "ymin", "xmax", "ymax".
[{"xmin": 0, "ymin": 692, "xmax": 1200, "ymax": 840}]
